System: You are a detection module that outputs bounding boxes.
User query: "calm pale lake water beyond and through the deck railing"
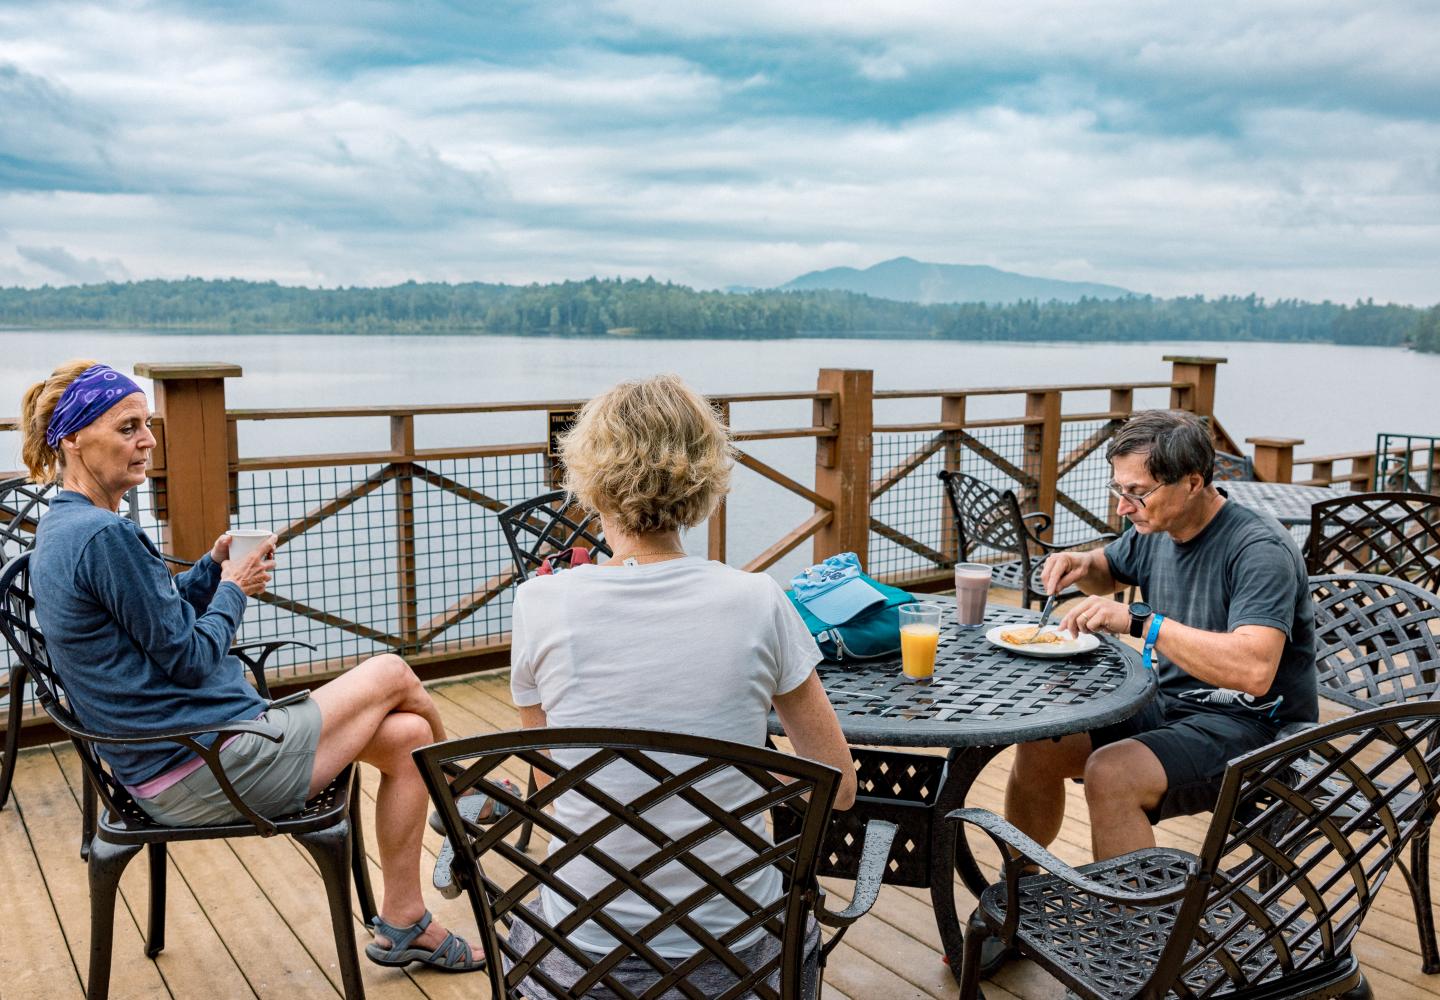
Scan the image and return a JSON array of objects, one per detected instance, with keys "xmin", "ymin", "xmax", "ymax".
[{"xmin": 0, "ymin": 330, "xmax": 1440, "ymax": 668}]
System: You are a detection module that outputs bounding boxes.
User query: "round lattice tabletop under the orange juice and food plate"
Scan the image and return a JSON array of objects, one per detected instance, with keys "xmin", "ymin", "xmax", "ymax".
[{"xmin": 770, "ymin": 597, "xmax": 1155, "ymax": 746}]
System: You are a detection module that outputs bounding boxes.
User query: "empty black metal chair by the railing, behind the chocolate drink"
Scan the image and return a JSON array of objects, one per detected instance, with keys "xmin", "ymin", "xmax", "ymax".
[{"xmin": 937, "ymin": 470, "xmax": 1117, "ymax": 610}]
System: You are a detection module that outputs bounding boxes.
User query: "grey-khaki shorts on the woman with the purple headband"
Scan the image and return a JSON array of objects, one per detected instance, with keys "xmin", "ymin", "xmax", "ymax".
[{"xmin": 135, "ymin": 697, "xmax": 321, "ymax": 827}]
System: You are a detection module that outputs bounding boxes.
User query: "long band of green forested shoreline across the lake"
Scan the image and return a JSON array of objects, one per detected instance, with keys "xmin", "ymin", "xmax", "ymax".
[{"xmin": 0, "ymin": 278, "xmax": 1440, "ymax": 352}]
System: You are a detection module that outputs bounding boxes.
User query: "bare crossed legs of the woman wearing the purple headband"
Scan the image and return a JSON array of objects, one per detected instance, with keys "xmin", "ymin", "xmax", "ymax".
[{"xmin": 310, "ymin": 654, "xmax": 463, "ymax": 948}]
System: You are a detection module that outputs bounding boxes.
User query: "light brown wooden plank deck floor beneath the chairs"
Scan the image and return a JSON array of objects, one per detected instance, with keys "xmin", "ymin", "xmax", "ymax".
[{"xmin": 8, "ymin": 674, "xmax": 1440, "ymax": 1000}]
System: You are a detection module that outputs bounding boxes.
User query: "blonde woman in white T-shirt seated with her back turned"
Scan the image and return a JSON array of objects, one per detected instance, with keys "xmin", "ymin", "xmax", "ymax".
[{"xmin": 511, "ymin": 375, "xmax": 855, "ymax": 985}]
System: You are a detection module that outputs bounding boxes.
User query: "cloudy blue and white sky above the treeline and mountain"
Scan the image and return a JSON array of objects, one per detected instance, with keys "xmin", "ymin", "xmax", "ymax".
[{"xmin": 0, "ymin": 0, "xmax": 1440, "ymax": 304}]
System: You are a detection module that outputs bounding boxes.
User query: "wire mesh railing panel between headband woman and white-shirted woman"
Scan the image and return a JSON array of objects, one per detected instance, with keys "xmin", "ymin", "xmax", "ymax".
[{"xmin": 233, "ymin": 455, "xmax": 549, "ymax": 677}]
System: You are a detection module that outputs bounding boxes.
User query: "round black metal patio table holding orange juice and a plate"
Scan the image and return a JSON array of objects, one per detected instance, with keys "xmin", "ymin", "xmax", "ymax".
[{"xmin": 770, "ymin": 597, "xmax": 1155, "ymax": 976}]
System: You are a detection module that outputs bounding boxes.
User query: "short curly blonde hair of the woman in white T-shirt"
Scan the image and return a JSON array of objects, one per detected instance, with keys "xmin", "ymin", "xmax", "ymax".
[{"xmin": 560, "ymin": 375, "xmax": 734, "ymax": 535}]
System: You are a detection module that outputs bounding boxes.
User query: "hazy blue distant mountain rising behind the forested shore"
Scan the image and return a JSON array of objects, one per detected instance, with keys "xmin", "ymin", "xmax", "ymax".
[{"xmin": 780, "ymin": 256, "xmax": 1132, "ymax": 305}]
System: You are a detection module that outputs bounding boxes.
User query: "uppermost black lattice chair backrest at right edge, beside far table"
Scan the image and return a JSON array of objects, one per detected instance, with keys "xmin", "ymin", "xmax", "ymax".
[{"xmin": 1305, "ymin": 493, "xmax": 1440, "ymax": 592}]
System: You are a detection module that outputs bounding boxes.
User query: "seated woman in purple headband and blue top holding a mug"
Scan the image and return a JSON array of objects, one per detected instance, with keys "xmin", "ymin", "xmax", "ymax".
[{"xmin": 20, "ymin": 360, "xmax": 484, "ymax": 971}]
